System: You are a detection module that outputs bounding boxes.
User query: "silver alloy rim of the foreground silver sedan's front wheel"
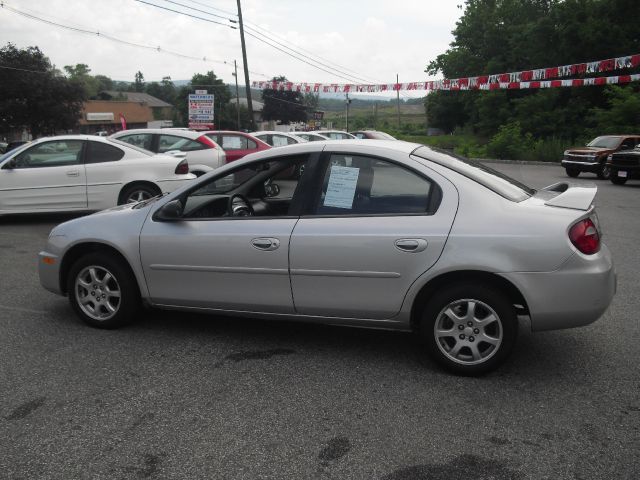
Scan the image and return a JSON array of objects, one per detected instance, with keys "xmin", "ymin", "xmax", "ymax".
[{"xmin": 75, "ymin": 265, "xmax": 122, "ymax": 321}]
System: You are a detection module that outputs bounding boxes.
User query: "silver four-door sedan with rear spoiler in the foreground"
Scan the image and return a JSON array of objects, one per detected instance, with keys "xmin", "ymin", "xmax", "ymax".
[{"xmin": 39, "ymin": 140, "xmax": 616, "ymax": 375}]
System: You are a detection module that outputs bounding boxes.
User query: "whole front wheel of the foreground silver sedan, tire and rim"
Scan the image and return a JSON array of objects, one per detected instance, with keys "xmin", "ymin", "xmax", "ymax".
[{"xmin": 67, "ymin": 253, "xmax": 140, "ymax": 329}]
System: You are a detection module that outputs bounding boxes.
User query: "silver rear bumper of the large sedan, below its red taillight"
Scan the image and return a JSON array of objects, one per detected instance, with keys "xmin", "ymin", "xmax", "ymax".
[{"xmin": 503, "ymin": 244, "xmax": 617, "ymax": 331}]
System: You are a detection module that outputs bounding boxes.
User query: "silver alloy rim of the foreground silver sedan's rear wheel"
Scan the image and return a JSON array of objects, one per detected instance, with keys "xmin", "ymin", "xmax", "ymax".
[{"xmin": 433, "ymin": 299, "xmax": 504, "ymax": 365}]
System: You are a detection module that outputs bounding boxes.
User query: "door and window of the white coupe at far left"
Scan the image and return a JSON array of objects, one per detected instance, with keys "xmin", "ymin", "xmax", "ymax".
[{"xmin": 0, "ymin": 140, "xmax": 87, "ymax": 212}]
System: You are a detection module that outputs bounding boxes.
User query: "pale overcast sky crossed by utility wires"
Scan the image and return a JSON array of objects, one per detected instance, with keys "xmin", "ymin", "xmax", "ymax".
[{"xmin": 0, "ymin": 0, "xmax": 462, "ymax": 97}]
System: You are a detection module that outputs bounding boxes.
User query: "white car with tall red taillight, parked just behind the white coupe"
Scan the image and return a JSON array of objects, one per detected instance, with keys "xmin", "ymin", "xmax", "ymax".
[{"xmin": 111, "ymin": 128, "xmax": 227, "ymax": 177}]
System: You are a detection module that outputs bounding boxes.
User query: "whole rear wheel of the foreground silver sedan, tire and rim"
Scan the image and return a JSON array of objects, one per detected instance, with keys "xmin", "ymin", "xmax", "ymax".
[{"xmin": 420, "ymin": 284, "xmax": 518, "ymax": 376}]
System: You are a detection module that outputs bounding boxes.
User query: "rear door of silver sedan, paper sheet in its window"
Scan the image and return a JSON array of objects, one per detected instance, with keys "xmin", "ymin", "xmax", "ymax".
[{"xmin": 289, "ymin": 147, "xmax": 458, "ymax": 319}]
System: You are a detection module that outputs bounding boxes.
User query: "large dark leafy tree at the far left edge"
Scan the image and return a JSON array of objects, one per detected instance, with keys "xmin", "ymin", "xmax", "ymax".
[{"xmin": 0, "ymin": 43, "xmax": 86, "ymax": 137}]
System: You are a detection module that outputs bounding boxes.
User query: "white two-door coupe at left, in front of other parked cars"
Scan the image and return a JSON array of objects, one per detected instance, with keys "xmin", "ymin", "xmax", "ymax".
[{"xmin": 0, "ymin": 135, "xmax": 195, "ymax": 214}]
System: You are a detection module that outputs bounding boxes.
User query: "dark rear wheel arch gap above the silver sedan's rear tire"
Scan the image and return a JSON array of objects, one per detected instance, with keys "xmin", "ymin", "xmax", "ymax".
[{"xmin": 411, "ymin": 270, "xmax": 529, "ymax": 331}]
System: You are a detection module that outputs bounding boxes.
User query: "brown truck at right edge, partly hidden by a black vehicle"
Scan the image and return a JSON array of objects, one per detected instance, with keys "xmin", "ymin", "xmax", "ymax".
[{"xmin": 561, "ymin": 135, "xmax": 640, "ymax": 180}]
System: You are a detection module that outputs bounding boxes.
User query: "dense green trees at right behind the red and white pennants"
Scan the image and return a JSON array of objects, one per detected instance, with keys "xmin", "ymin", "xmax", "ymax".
[{"xmin": 425, "ymin": 0, "xmax": 640, "ymax": 159}]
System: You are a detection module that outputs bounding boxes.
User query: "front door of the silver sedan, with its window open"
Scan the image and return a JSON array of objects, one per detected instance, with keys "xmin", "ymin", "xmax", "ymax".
[{"xmin": 140, "ymin": 155, "xmax": 314, "ymax": 314}]
